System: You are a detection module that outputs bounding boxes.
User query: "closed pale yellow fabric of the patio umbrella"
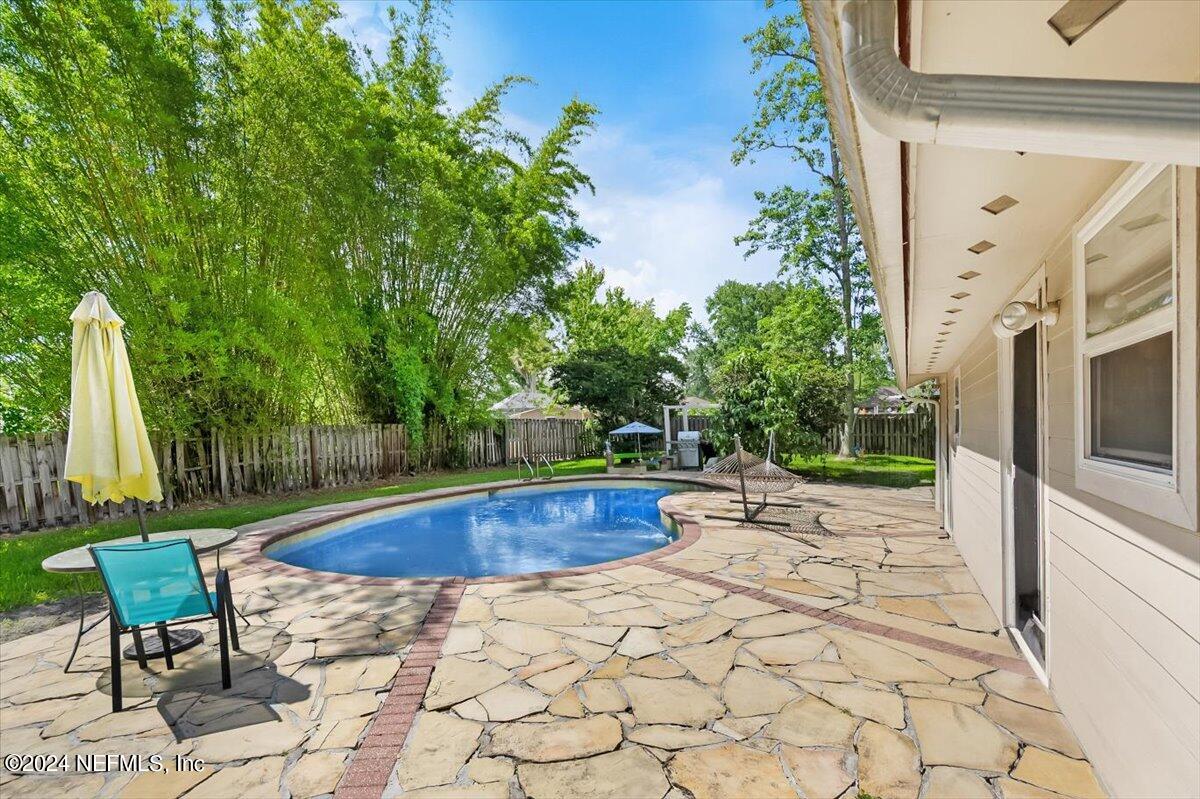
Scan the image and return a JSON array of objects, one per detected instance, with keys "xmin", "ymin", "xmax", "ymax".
[{"xmin": 66, "ymin": 292, "xmax": 162, "ymax": 504}]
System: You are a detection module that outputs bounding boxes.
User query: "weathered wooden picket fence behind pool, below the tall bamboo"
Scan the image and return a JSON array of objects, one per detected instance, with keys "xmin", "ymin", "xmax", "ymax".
[{"xmin": 0, "ymin": 419, "xmax": 601, "ymax": 533}]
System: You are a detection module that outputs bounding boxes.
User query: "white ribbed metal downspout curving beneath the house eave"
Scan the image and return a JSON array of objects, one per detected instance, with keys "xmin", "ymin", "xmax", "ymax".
[{"xmin": 841, "ymin": 0, "xmax": 1200, "ymax": 166}]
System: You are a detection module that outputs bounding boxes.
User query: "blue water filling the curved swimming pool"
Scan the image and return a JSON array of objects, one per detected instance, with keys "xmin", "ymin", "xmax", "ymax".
[{"xmin": 265, "ymin": 481, "xmax": 688, "ymax": 577}]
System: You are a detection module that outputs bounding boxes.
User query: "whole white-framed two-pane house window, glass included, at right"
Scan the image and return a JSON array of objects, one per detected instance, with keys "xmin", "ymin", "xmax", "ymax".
[{"xmin": 1074, "ymin": 164, "xmax": 1195, "ymax": 527}]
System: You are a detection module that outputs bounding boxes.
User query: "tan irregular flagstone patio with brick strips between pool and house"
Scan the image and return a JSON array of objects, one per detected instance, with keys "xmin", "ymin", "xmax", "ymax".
[{"xmin": 0, "ymin": 475, "xmax": 1104, "ymax": 799}]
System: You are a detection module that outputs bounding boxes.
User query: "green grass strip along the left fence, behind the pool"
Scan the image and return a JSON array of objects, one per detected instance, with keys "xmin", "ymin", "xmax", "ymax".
[{"xmin": 0, "ymin": 457, "xmax": 604, "ymax": 613}]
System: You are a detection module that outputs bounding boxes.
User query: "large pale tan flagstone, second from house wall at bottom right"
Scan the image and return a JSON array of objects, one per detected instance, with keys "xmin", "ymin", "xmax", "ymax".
[{"xmin": 908, "ymin": 698, "xmax": 1016, "ymax": 773}]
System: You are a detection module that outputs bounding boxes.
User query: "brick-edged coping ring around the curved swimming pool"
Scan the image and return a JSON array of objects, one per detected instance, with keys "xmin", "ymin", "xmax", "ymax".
[{"xmin": 227, "ymin": 473, "xmax": 730, "ymax": 588}]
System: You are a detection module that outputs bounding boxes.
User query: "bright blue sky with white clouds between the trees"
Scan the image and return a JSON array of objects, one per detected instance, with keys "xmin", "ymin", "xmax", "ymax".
[{"xmin": 337, "ymin": 0, "xmax": 802, "ymax": 319}]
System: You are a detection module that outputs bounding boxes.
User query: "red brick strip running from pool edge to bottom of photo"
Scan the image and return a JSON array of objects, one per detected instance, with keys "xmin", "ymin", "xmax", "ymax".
[{"xmin": 334, "ymin": 578, "xmax": 467, "ymax": 799}]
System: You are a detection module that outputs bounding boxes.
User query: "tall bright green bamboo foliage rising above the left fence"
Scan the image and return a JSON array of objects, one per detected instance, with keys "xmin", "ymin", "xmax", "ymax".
[{"xmin": 0, "ymin": 0, "xmax": 595, "ymax": 432}]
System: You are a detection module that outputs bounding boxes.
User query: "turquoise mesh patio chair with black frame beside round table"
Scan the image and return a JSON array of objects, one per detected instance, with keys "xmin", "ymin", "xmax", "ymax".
[{"xmin": 88, "ymin": 539, "xmax": 240, "ymax": 713}]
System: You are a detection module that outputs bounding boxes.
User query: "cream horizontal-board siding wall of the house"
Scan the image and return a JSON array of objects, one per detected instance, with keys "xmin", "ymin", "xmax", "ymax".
[{"xmin": 946, "ymin": 168, "xmax": 1200, "ymax": 797}]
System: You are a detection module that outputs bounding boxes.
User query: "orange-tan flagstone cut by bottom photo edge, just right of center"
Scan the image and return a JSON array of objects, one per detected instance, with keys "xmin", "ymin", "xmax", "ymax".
[{"xmin": 671, "ymin": 744, "xmax": 796, "ymax": 799}]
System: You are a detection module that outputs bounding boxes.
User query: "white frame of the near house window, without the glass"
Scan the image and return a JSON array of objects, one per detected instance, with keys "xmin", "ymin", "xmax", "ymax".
[{"xmin": 1072, "ymin": 163, "xmax": 1196, "ymax": 529}]
